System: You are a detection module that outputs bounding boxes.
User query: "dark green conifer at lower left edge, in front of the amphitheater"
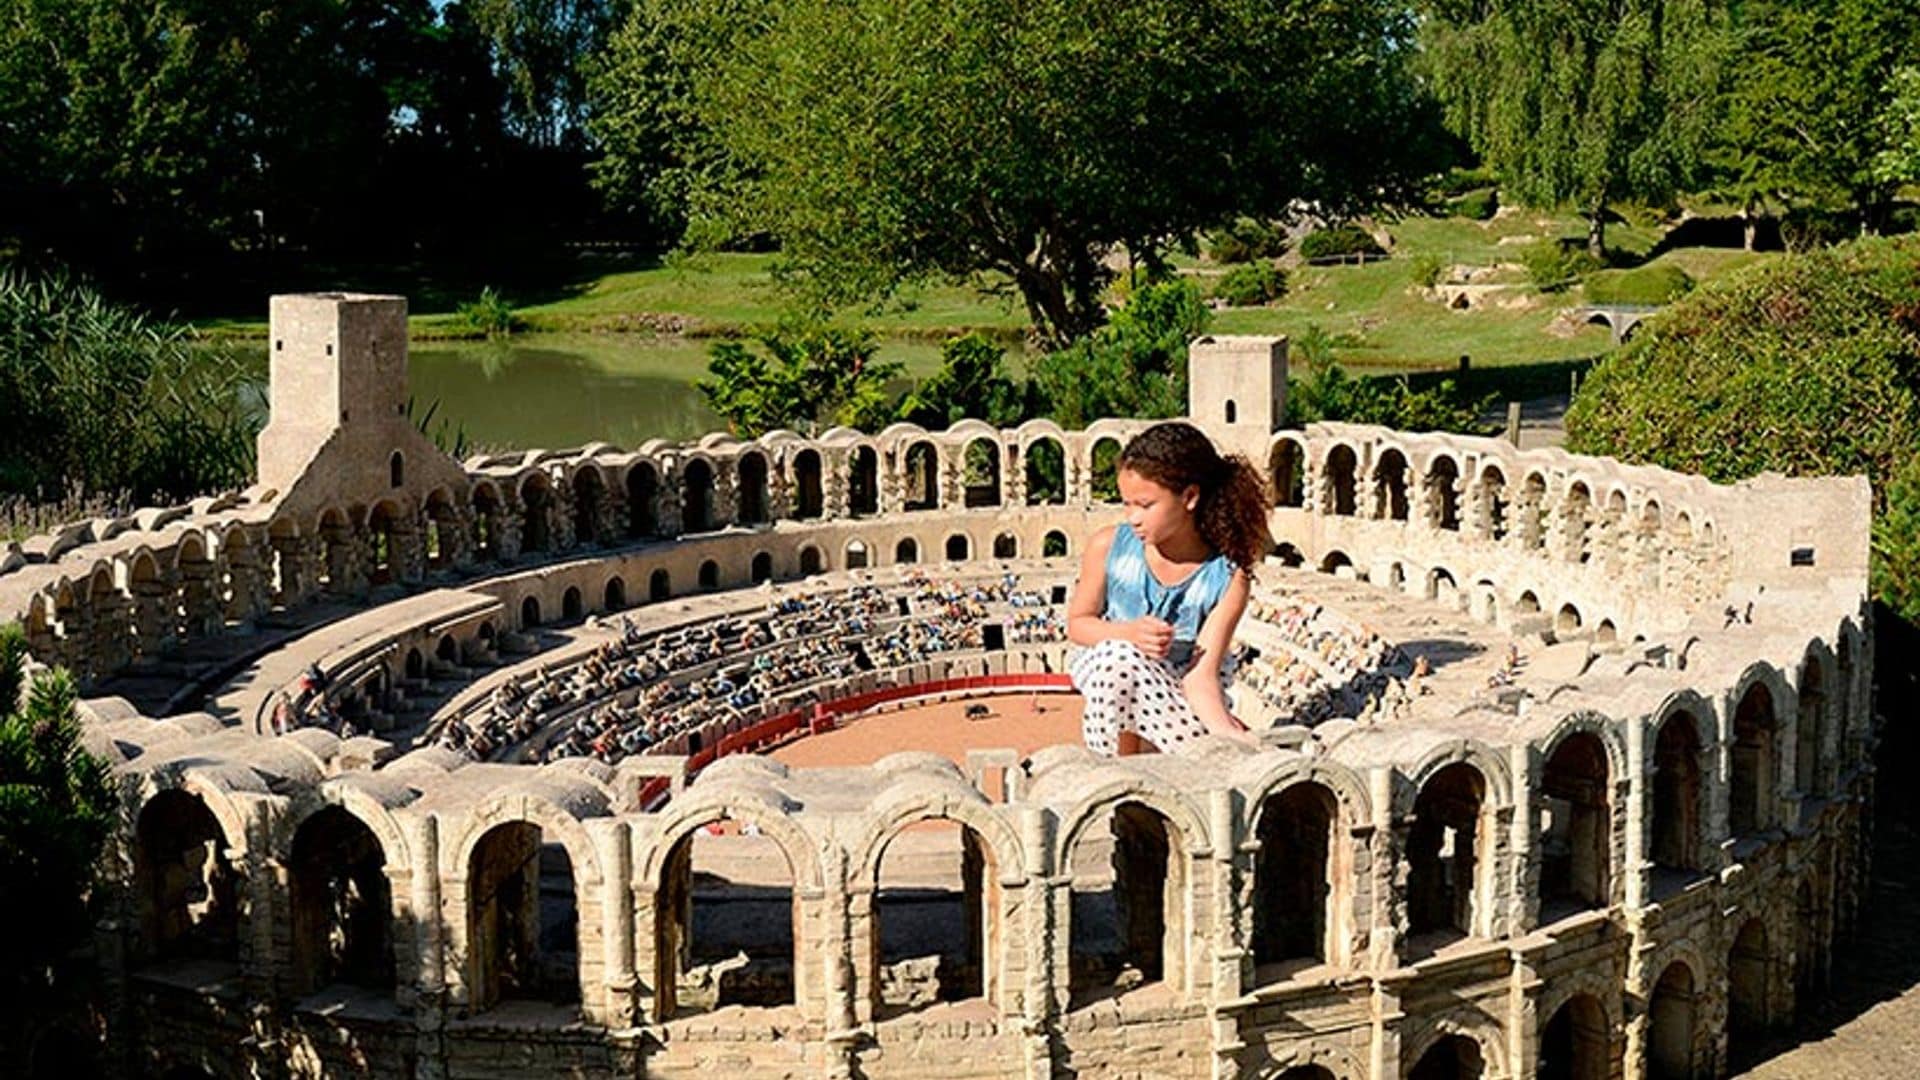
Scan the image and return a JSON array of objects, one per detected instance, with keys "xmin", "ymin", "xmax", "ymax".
[{"xmin": 0, "ymin": 625, "xmax": 115, "ymax": 1061}]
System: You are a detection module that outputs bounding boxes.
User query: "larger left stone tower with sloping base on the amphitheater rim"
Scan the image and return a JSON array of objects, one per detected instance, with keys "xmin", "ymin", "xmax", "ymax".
[{"xmin": 257, "ymin": 292, "xmax": 465, "ymax": 505}]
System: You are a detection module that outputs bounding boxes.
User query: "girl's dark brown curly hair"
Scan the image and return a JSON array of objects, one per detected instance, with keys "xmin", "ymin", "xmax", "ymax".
[{"xmin": 1117, "ymin": 421, "xmax": 1273, "ymax": 577}]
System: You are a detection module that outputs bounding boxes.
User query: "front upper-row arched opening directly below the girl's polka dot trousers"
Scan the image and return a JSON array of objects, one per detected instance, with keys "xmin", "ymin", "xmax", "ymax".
[{"xmin": 1068, "ymin": 801, "xmax": 1187, "ymax": 1005}]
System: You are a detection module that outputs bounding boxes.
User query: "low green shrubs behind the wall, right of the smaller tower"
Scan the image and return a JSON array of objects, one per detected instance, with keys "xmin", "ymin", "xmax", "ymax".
[{"xmin": 1286, "ymin": 327, "xmax": 1494, "ymax": 434}]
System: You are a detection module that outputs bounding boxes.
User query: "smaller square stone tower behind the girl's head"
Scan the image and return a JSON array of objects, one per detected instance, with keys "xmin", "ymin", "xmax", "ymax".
[{"xmin": 1187, "ymin": 334, "xmax": 1286, "ymax": 467}]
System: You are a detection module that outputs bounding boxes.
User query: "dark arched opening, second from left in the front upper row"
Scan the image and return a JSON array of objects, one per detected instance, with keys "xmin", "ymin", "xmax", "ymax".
[{"xmin": 288, "ymin": 805, "xmax": 394, "ymax": 994}]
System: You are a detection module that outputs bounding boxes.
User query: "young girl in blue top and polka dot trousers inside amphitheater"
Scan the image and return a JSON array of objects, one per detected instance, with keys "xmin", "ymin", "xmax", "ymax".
[{"xmin": 1068, "ymin": 421, "xmax": 1271, "ymax": 755}]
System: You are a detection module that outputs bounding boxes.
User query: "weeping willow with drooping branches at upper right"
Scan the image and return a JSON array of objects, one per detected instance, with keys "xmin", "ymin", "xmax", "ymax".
[{"xmin": 1423, "ymin": 0, "xmax": 1726, "ymax": 259}]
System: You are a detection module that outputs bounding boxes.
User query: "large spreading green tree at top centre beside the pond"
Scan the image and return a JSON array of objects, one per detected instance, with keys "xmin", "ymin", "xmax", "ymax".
[{"xmin": 595, "ymin": 0, "xmax": 1425, "ymax": 346}]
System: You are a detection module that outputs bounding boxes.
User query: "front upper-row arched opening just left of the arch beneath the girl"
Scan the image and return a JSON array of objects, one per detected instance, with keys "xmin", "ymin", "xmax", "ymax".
[{"xmin": 868, "ymin": 819, "xmax": 1000, "ymax": 1017}]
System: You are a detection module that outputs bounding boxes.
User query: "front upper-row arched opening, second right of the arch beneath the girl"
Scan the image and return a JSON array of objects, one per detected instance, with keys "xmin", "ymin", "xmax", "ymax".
[{"xmin": 1405, "ymin": 763, "xmax": 1486, "ymax": 947}]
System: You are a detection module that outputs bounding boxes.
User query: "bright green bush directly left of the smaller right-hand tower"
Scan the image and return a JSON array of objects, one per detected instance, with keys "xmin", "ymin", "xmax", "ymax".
[{"xmin": 1031, "ymin": 279, "xmax": 1212, "ymax": 429}]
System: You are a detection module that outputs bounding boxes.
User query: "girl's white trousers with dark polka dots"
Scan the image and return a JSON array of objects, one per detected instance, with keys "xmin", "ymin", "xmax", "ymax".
[{"xmin": 1068, "ymin": 640, "xmax": 1208, "ymax": 757}]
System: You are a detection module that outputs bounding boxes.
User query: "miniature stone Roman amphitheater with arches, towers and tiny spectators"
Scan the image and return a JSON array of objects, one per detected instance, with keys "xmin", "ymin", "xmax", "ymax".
[{"xmin": 0, "ymin": 294, "xmax": 1876, "ymax": 1080}]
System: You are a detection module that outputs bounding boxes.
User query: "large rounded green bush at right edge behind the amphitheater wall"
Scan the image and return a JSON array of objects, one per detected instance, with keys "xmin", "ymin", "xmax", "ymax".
[{"xmin": 1567, "ymin": 236, "xmax": 1920, "ymax": 619}]
